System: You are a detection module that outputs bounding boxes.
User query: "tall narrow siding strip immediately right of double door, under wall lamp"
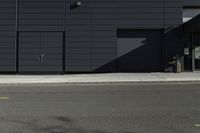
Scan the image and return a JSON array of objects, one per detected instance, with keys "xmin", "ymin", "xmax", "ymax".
[{"xmin": 66, "ymin": 0, "xmax": 91, "ymax": 72}]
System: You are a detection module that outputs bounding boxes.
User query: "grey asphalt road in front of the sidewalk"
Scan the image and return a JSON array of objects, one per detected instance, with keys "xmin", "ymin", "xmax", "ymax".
[{"xmin": 0, "ymin": 83, "xmax": 200, "ymax": 133}]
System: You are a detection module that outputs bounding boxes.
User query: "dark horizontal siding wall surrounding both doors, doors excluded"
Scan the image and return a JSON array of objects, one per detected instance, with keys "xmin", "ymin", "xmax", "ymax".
[{"xmin": 0, "ymin": 0, "xmax": 182, "ymax": 72}]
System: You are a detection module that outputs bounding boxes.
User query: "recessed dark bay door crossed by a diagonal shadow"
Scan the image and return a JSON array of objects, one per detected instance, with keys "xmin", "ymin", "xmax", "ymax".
[{"xmin": 117, "ymin": 29, "xmax": 163, "ymax": 72}]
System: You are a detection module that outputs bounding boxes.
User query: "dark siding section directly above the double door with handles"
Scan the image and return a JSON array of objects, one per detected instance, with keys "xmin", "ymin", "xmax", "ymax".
[{"xmin": 19, "ymin": 0, "xmax": 65, "ymax": 31}]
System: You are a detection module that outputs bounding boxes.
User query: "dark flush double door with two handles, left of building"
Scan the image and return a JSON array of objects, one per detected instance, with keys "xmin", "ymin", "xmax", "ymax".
[{"xmin": 18, "ymin": 32, "xmax": 63, "ymax": 73}]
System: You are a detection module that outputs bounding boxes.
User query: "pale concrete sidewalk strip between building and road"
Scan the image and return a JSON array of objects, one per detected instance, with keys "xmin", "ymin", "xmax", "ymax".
[{"xmin": 0, "ymin": 72, "xmax": 200, "ymax": 84}]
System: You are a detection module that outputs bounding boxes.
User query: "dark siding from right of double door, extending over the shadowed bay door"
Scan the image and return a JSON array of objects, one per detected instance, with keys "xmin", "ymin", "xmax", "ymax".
[{"xmin": 66, "ymin": 0, "xmax": 182, "ymax": 71}]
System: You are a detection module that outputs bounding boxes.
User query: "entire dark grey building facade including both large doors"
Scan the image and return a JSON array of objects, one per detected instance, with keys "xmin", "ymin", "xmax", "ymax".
[{"xmin": 0, "ymin": 0, "xmax": 197, "ymax": 73}]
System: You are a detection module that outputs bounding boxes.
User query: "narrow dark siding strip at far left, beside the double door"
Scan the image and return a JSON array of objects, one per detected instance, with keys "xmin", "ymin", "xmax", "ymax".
[{"xmin": 0, "ymin": 0, "xmax": 16, "ymax": 72}]
